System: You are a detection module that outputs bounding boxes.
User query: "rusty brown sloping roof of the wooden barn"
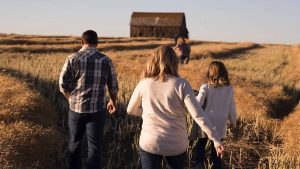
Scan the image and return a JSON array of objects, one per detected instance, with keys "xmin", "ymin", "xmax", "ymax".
[{"xmin": 130, "ymin": 12, "xmax": 186, "ymax": 27}]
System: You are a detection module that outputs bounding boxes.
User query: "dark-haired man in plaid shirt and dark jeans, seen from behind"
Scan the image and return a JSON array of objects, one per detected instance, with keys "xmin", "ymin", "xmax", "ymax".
[{"xmin": 59, "ymin": 30, "xmax": 118, "ymax": 169}]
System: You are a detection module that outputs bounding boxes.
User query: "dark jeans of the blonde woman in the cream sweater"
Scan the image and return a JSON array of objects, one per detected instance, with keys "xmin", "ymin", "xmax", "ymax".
[{"xmin": 139, "ymin": 148, "xmax": 187, "ymax": 169}]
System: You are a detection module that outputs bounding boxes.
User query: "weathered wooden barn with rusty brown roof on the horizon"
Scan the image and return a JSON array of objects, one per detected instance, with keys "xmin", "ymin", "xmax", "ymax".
[{"xmin": 130, "ymin": 12, "xmax": 189, "ymax": 38}]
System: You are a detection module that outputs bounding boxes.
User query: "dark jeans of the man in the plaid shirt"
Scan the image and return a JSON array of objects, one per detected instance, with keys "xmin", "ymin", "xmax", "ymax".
[{"xmin": 68, "ymin": 109, "xmax": 106, "ymax": 169}]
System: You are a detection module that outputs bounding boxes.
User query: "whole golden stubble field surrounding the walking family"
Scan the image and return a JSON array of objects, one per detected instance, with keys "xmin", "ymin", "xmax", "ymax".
[{"xmin": 0, "ymin": 34, "xmax": 300, "ymax": 169}]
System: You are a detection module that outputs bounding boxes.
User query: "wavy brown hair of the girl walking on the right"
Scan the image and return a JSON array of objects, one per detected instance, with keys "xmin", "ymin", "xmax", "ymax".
[{"xmin": 207, "ymin": 61, "xmax": 230, "ymax": 87}]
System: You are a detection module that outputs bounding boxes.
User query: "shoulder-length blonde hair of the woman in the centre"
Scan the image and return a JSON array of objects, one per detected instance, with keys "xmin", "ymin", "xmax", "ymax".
[{"xmin": 142, "ymin": 46, "xmax": 178, "ymax": 81}]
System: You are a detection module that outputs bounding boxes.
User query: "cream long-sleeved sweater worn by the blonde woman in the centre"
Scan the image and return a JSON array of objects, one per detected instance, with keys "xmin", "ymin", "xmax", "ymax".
[{"xmin": 127, "ymin": 76, "xmax": 222, "ymax": 156}]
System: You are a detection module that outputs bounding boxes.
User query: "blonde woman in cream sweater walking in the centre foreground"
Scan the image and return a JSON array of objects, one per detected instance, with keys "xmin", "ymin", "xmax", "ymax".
[{"xmin": 127, "ymin": 46, "xmax": 224, "ymax": 169}]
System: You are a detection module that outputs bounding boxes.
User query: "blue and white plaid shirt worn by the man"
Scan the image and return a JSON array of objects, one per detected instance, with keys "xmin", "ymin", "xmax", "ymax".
[{"xmin": 59, "ymin": 47, "xmax": 118, "ymax": 113}]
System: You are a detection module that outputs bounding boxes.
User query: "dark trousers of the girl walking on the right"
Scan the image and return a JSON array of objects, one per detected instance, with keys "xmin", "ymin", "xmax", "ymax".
[{"xmin": 196, "ymin": 138, "xmax": 223, "ymax": 169}]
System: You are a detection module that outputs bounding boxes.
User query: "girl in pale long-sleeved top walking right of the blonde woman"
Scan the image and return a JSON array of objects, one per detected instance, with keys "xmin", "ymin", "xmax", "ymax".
[{"xmin": 193, "ymin": 61, "xmax": 236, "ymax": 169}]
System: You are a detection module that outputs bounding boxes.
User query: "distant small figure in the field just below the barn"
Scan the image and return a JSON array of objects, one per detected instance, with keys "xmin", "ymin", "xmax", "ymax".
[{"xmin": 174, "ymin": 36, "xmax": 191, "ymax": 64}]
